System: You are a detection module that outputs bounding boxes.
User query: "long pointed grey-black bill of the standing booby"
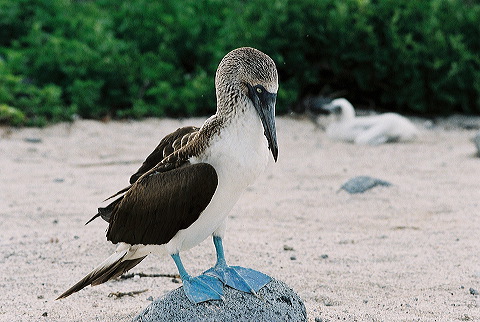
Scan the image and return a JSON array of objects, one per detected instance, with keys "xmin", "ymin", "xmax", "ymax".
[{"xmin": 247, "ymin": 84, "xmax": 278, "ymax": 162}]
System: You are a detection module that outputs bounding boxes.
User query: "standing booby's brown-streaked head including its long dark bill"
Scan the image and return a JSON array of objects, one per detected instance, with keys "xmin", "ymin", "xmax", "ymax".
[{"xmin": 215, "ymin": 47, "xmax": 278, "ymax": 161}]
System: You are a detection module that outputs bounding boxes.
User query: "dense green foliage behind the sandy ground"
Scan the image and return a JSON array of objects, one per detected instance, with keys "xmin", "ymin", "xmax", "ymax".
[{"xmin": 0, "ymin": 0, "xmax": 480, "ymax": 125}]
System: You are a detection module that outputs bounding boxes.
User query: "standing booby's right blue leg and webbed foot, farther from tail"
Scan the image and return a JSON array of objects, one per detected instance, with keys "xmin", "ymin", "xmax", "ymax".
[{"xmin": 203, "ymin": 236, "xmax": 272, "ymax": 294}]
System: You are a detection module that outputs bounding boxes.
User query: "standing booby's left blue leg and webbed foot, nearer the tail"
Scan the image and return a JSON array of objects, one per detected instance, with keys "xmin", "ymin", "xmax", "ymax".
[{"xmin": 172, "ymin": 254, "xmax": 223, "ymax": 304}]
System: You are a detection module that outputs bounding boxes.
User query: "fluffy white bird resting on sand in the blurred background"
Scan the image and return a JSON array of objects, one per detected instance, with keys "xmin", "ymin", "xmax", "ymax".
[{"xmin": 323, "ymin": 98, "xmax": 419, "ymax": 145}]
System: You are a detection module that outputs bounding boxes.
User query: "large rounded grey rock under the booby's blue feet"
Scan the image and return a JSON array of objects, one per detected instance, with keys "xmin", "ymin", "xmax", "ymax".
[{"xmin": 133, "ymin": 279, "xmax": 307, "ymax": 322}]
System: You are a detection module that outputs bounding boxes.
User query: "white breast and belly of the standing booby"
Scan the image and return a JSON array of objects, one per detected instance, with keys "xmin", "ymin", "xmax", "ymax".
[{"xmin": 166, "ymin": 115, "xmax": 270, "ymax": 254}]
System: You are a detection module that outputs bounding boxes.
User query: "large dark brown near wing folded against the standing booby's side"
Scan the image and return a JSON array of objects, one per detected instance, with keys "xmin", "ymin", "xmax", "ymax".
[{"xmin": 107, "ymin": 161, "xmax": 218, "ymax": 245}]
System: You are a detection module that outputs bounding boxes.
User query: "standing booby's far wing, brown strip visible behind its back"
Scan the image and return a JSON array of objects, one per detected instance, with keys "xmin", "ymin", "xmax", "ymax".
[{"xmin": 130, "ymin": 126, "xmax": 199, "ymax": 183}]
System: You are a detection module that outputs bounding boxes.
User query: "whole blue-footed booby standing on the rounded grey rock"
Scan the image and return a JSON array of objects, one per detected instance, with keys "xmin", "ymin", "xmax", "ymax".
[{"xmin": 58, "ymin": 47, "xmax": 278, "ymax": 303}]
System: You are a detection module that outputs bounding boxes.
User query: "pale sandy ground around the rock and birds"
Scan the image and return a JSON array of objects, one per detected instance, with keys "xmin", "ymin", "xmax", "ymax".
[{"xmin": 0, "ymin": 116, "xmax": 480, "ymax": 321}]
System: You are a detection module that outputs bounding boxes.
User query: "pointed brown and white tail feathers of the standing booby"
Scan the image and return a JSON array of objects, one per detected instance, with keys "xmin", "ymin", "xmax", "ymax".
[{"xmin": 57, "ymin": 250, "xmax": 146, "ymax": 300}]
